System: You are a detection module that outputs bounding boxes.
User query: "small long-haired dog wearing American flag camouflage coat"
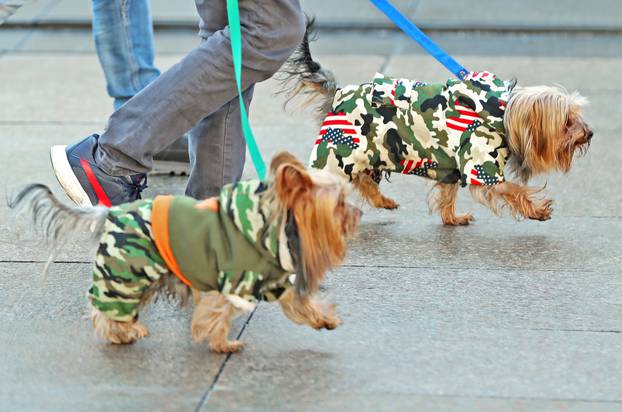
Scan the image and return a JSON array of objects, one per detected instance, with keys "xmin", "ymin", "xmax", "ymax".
[{"xmin": 281, "ymin": 22, "xmax": 593, "ymax": 225}]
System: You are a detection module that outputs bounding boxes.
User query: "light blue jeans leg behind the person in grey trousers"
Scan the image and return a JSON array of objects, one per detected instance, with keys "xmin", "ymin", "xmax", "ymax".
[{"xmin": 93, "ymin": 0, "xmax": 160, "ymax": 110}]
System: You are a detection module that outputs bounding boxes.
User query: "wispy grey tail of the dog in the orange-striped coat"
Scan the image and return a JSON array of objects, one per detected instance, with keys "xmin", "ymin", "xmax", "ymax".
[{"xmin": 8, "ymin": 183, "xmax": 108, "ymax": 250}]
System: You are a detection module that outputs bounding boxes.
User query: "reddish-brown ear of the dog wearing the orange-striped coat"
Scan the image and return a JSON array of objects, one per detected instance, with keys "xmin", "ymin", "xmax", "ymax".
[{"xmin": 273, "ymin": 158, "xmax": 313, "ymax": 208}]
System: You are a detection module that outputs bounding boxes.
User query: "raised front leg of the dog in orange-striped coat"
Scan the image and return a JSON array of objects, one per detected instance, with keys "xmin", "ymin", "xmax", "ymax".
[{"xmin": 279, "ymin": 289, "xmax": 341, "ymax": 329}]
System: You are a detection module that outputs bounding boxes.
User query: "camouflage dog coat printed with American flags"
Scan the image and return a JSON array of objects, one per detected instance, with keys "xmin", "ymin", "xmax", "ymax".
[{"xmin": 310, "ymin": 72, "xmax": 512, "ymax": 186}]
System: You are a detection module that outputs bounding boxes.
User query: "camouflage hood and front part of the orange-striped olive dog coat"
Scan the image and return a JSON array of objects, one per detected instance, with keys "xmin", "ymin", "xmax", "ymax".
[{"xmin": 218, "ymin": 180, "xmax": 294, "ymax": 303}]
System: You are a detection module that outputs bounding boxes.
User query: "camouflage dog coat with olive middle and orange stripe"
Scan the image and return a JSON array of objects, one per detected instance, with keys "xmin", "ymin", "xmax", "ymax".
[{"xmin": 89, "ymin": 180, "xmax": 300, "ymax": 322}]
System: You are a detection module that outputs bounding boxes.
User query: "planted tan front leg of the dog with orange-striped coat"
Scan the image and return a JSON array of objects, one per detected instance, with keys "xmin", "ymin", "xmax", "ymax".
[{"xmin": 192, "ymin": 293, "xmax": 244, "ymax": 353}]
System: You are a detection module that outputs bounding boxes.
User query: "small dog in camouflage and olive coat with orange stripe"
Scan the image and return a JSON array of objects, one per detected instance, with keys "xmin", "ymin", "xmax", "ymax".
[{"xmin": 9, "ymin": 152, "xmax": 361, "ymax": 353}]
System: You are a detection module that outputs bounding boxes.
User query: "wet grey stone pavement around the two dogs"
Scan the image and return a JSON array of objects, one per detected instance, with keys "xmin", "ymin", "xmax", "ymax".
[{"xmin": 0, "ymin": 0, "xmax": 622, "ymax": 411}]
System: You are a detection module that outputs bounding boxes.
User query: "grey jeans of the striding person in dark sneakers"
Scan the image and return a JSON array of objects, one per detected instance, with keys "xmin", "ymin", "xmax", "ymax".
[{"xmin": 94, "ymin": 0, "xmax": 305, "ymax": 198}]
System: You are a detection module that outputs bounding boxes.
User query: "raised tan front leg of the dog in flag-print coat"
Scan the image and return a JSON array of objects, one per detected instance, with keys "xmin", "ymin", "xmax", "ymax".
[{"xmin": 471, "ymin": 182, "xmax": 553, "ymax": 221}]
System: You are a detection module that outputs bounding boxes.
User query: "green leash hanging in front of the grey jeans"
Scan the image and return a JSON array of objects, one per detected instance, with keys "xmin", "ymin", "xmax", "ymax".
[{"xmin": 227, "ymin": 0, "xmax": 266, "ymax": 180}]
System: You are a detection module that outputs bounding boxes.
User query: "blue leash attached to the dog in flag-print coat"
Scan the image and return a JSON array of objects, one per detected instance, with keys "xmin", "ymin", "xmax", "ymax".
[{"xmin": 370, "ymin": 0, "xmax": 469, "ymax": 80}]
